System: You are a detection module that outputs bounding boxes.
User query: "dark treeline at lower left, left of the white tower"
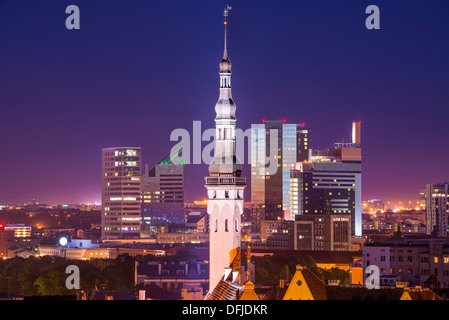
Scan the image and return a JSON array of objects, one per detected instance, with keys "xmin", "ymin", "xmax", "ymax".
[{"xmin": 0, "ymin": 255, "xmax": 134, "ymax": 298}]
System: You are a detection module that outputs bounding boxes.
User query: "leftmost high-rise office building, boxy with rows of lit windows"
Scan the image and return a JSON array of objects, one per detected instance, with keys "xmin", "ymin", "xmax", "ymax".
[{"xmin": 101, "ymin": 147, "xmax": 141, "ymax": 240}]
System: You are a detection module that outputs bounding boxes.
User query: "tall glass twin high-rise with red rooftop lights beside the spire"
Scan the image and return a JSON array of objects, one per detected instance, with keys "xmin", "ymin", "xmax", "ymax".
[{"xmin": 251, "ymin": 120, "xmax": 311, "ymax": 231}]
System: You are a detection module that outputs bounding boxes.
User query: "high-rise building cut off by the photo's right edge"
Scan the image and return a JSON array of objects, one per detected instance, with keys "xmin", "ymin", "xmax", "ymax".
[{"xmin": 425, "ymin": 182, "xmax": 449, "ymax": 237}]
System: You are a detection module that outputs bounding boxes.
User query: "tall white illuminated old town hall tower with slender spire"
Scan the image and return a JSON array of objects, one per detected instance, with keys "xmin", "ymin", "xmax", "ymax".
[{"xmin": 205, "ymin": 10, "xmax": 246, "ymax": 291}]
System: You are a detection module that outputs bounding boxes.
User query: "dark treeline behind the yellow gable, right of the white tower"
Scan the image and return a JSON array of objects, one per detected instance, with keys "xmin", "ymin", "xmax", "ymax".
[{"xmin": 251, "ymin": 255, "xmax": 350, "ymax": 285}]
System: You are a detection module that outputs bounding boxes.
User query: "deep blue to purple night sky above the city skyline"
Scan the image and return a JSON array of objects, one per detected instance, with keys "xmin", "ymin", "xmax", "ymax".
[{"xmin": 0, "ymin": 0, "xmax": 449, "ymax": 204}]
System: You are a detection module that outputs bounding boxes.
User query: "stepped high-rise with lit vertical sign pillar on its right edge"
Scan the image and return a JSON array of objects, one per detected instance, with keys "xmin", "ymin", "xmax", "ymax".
[{"xmin": 290, "ymin": 121, "xmax": 362, "ymax": 236}]
